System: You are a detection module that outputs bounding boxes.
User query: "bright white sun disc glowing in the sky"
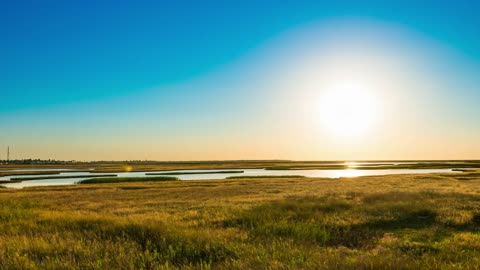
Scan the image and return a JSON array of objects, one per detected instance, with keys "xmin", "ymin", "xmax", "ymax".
[{"xmin": 320, "ymin": 82, "xmax": 379, "ymax": 138}]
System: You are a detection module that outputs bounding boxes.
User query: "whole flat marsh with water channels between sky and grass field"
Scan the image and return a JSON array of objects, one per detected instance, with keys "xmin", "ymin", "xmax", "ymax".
[{"xmin": 0, "ymin": 160, "xmax": 472, "ymax": 188}]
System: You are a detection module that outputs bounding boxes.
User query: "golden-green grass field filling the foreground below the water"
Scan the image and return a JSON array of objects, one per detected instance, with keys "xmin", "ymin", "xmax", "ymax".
[{"xmin": 0, "ymin": 172, "xmax": 480, "ymax": 269}]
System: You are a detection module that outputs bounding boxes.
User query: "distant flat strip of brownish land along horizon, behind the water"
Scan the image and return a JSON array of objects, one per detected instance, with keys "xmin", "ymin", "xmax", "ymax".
[{"xmin": 0, "ymin": 160, "xmax": 480, "ymax": 176}]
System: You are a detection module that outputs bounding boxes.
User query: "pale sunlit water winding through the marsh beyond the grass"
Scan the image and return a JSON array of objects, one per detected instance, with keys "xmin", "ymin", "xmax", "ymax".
[{"xmin": 0, "ymin": 169, "xmax": 452, "ymax": 188}]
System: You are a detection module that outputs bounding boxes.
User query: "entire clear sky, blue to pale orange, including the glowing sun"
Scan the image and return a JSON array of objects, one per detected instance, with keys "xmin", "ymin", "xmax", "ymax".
[{"xmin": 0, "ymin": 0, "xmax": 480, "ymax": 160}]
